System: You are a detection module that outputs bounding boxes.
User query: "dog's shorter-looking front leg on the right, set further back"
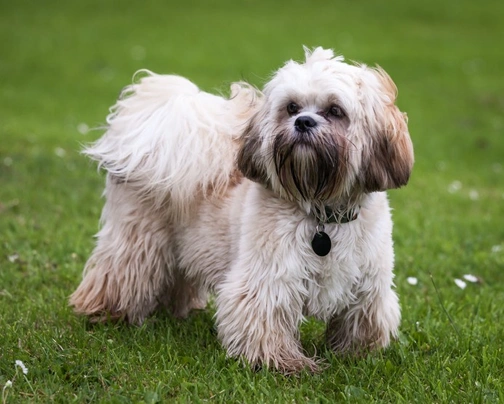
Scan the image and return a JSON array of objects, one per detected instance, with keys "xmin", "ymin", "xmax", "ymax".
[{"xmin": 326, "ymin": 274, "xmax": 401, "ymax": 353}]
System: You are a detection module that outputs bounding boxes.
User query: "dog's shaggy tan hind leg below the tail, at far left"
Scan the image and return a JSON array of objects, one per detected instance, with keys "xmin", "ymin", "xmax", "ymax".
[{"xmin": 70, "ymin": 178, "xmax": 176, "ymax": 324}]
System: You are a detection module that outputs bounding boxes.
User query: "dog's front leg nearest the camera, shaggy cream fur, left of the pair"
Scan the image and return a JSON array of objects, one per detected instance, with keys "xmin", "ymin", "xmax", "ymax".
[{"xmin": 216, "ymin": 257, "xmax": 317, "ymax": 373}]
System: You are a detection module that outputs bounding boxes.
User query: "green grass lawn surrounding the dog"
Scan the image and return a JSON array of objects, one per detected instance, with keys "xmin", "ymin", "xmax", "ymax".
[{"xmin": 0, "ymin": 0, "xmax": 504, "ymax": 403}]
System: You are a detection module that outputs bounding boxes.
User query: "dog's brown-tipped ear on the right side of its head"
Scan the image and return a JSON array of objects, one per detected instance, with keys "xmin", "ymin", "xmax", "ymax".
[{"xmin": 363, "ymin": 68, "xmax": 414, "ymax": 192}]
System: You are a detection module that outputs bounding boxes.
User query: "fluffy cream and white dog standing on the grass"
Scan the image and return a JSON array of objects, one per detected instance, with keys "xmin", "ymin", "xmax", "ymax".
[{"xmin": 70, "ymin": 47, "xmax": 414, "ymax": 373}]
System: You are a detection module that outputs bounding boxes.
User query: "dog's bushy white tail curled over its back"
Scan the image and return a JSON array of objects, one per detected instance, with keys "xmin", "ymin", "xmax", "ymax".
[{"xmin": 84, "ymin": 71, "xmax": 261, "ymax": 219}]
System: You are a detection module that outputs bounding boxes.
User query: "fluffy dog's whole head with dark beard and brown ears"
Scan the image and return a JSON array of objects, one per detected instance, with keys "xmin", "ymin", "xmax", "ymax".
[{"xmin": 238, "ymin": 48, "xmax": 413, "ymax": 204}]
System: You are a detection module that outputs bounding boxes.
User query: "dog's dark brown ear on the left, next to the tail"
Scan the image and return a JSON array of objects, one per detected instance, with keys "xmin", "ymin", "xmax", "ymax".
[{"xmin": 236, "ymin": 114, "xmax": 268, "ymax": 184}]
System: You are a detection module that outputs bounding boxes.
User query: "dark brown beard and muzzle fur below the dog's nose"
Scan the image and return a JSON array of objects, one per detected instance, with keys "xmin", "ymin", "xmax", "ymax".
[{"xmin": 273, "ymin": 131, "xmax": 347, "ymax": 201}]
